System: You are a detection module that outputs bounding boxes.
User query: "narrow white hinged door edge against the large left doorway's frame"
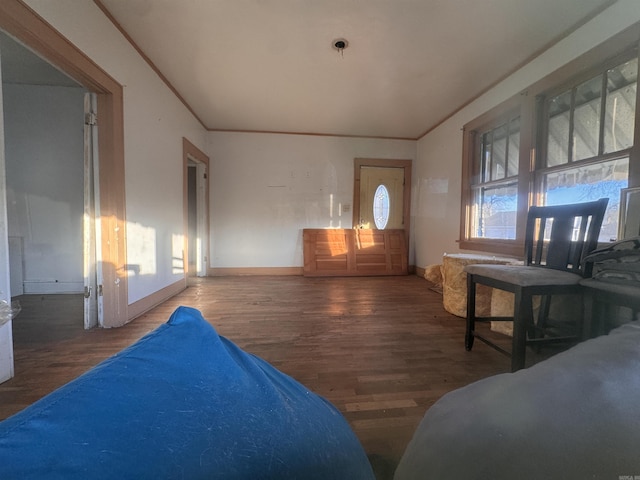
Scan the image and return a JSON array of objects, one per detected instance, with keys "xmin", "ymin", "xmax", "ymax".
[{"xmin": 83, "ymin": 93, "xmax": 103, "ymax": 329}]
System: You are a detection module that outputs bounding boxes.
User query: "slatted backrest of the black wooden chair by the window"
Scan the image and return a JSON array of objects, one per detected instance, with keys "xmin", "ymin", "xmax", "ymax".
[{"xmin": 525, "ymin": 198, "xmax": 609, "ymax": 276}]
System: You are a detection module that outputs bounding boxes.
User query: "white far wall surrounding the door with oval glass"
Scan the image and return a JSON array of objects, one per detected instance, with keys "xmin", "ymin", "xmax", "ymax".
[{"xmin": 207, "ymin": 132, "xmax": 416, "ymax": 268}]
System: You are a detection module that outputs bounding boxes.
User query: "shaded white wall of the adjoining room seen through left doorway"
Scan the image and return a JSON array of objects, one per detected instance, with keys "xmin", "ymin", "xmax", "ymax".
[{"xmin": 3, "ymin": 84, "xmax": 84, "ymax": 294}]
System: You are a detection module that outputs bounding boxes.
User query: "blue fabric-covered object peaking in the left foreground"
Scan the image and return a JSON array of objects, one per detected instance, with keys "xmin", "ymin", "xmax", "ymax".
[{"xmin": 0, "ymin": 307, "xmax": 374, "ymax": 480}]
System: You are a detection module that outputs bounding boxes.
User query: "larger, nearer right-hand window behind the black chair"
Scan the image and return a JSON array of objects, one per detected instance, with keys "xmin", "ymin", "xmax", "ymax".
[{"xmin": 536, "ymin": 57, "xmax": 638, "ymax": 242}]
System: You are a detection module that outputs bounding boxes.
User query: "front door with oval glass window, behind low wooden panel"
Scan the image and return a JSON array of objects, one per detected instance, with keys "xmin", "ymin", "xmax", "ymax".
[{"xmin": 358, "ymin": 165, "xmax": 405, "ymax": 230}]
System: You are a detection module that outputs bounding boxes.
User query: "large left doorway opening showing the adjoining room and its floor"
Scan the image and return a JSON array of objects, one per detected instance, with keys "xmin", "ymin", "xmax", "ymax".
[{"xmin": 0, "ymin": 32, "xmax": 95, "ymax": 370}]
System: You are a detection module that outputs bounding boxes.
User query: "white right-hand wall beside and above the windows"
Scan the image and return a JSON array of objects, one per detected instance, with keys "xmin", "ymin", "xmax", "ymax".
[{"xmin": 413, "ymin": 0, "xmax": 640, "ymax": 267}]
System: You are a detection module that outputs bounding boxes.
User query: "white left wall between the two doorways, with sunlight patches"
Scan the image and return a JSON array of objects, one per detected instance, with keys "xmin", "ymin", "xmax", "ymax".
[{"xmin": 26, "ymin": 0, "xmax": 205, "ymax": 303}]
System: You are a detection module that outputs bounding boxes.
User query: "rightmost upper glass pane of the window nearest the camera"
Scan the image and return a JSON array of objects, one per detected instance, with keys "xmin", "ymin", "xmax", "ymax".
[{"xmin": 604, "ymin": 58, "xmax": 638, "ymax": 153}]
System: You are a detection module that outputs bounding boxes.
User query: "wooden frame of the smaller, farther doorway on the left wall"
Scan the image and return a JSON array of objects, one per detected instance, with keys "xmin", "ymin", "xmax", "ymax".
[{"xmin": 182, "ymin": 137, "xmax": 211, "ymax": 280}]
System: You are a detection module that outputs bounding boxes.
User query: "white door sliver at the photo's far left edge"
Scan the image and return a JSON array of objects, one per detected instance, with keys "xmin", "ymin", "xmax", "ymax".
[{"xmin": 0, "ymin": 44, "xmax": 13, "ymax": 383}]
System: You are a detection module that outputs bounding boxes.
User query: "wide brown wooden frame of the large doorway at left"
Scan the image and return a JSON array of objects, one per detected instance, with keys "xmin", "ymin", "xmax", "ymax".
[{"xmin": 0, "ymin": 0, "xmax": 129, "ymax": 327}]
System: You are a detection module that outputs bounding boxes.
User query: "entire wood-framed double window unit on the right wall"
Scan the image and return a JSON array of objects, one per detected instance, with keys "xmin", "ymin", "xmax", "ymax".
[{"xmin": 460, "ymin": 36, "xmax": 640, "ymax": 255}]
